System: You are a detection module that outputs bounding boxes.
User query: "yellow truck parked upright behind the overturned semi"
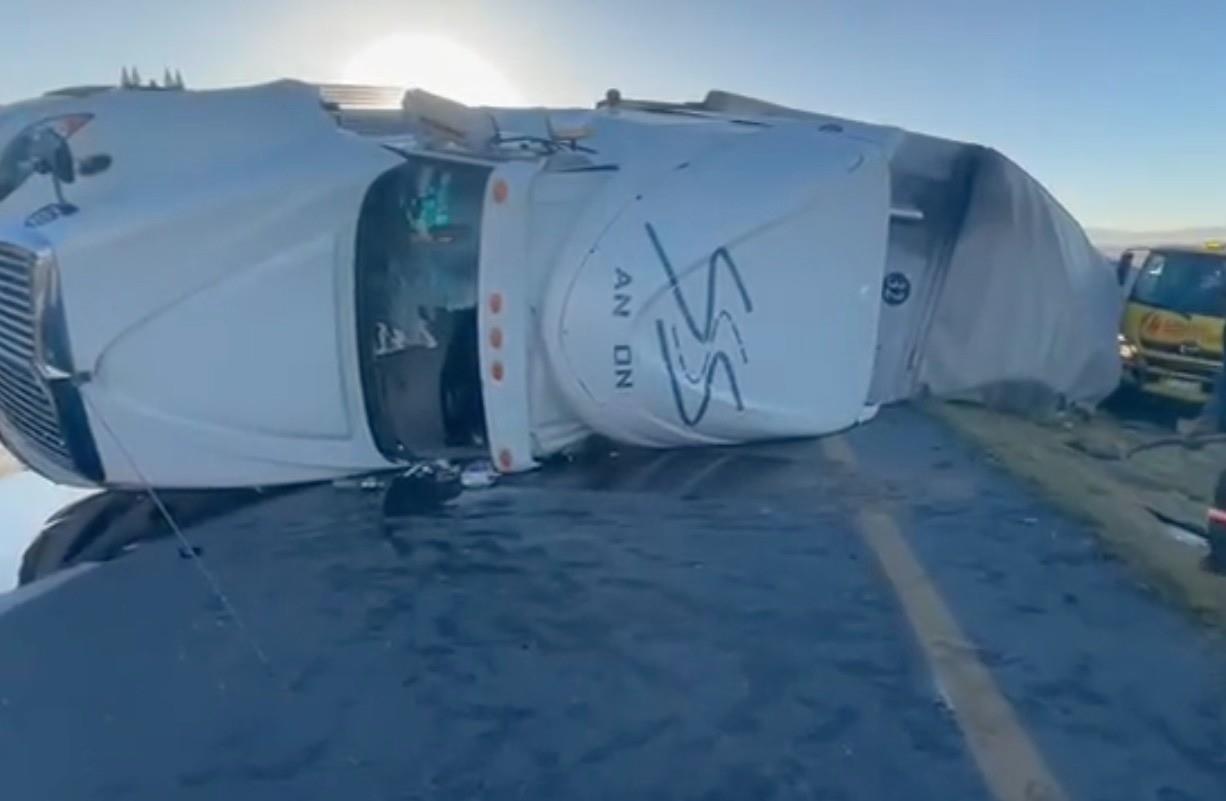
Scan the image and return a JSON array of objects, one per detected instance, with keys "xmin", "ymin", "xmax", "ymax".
[{"xmin": 1119, "ymin": 243, "xmax": 1226, "ymax": 404}]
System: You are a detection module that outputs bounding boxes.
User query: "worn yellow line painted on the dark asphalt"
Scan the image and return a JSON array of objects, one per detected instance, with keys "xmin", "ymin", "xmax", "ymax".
[{"xmin": 821, "ymin": 437, "xmax": 1068, "ymax": 801}]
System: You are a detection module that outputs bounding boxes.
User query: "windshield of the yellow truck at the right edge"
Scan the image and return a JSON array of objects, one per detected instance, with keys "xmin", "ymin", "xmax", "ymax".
[{"xmin": 1133, "ymin": 250, "xmax": 1226, "ymax": 316}]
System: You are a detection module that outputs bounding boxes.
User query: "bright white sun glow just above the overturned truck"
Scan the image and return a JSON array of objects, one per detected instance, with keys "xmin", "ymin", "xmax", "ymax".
[{"xmin": 343, "ymin": 33, "xmax": 521, "ymax": 105}]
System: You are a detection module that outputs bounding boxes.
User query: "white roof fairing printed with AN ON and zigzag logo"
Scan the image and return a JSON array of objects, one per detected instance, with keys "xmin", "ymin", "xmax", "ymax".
[{"xmin": 542, "ymin": 124, "xmax": 890, "ymax": 446}]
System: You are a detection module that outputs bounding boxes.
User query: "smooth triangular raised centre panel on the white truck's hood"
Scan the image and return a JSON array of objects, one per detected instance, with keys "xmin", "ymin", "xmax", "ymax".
[{"xmin": 94, "ymin": 236, "xmax": 351, "ymax": 439}]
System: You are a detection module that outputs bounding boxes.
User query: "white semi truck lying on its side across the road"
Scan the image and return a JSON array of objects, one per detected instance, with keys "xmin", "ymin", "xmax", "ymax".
[{"xmin": 0, "ymin": 82, "xmax": 1119, "ymax": 487}]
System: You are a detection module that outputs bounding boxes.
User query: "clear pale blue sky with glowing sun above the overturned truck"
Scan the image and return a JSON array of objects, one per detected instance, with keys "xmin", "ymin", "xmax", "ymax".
[{"xmin": 9, "ymin": 0, "xmax": 1226, "ymax": 228}]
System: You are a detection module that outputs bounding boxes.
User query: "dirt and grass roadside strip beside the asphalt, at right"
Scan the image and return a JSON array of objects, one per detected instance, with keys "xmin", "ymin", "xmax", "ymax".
[{"xmin": 926, "ymin": 399, "xmax": 1226, "ymax": 626}]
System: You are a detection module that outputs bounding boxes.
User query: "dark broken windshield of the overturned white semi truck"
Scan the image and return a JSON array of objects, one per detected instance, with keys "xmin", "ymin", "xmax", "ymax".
[{"xmin": 356, "ymin": 158, "xmax": 488, "ymax": 459}]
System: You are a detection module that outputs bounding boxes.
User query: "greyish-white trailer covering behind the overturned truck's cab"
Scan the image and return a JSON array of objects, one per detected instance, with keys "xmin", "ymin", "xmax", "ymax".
[{"xmin": 918, "ymin": 150, "xmax": 1122, "ymax": 406}]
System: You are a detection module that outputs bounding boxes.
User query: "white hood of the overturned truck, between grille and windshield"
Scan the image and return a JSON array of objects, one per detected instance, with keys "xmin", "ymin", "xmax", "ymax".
[{"xmin": 0, "ymin": 82, "xmax": 401, "ymax": 480}]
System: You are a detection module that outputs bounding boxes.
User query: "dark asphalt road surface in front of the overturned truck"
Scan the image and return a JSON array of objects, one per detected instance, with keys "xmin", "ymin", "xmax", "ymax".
[{"xmin": 0, "ymin": 408, "xmax": 1226, "ymax": 801}]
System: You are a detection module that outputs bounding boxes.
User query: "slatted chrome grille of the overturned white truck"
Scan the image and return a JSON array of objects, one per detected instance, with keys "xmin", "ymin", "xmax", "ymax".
[{"xmin": 0, "ymin": 243, "xmax": 72, "ymax": 470}]
